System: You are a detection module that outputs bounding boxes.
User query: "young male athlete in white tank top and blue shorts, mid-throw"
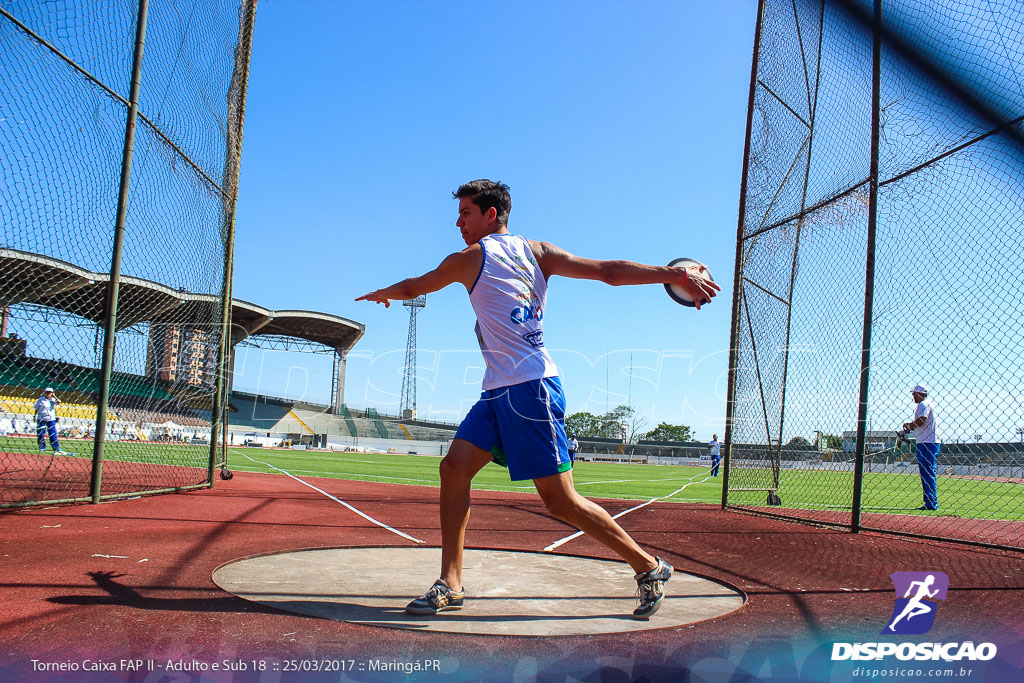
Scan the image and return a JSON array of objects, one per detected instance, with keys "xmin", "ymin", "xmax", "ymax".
[{"xmin": 356, "ymin": 180, "xmax": 720, "ymax": 620}]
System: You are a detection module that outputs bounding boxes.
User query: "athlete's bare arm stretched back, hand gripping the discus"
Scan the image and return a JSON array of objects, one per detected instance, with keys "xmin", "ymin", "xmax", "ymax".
[{"xmin": 529, "ymin": 242, "xmax": 722, "ymax": 310}]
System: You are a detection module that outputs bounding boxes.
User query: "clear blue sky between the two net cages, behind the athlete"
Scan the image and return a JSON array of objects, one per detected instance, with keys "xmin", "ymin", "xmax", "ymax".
[{"xmin": 234, "ymin": 0, "xmax": 757, "ymax": 437}]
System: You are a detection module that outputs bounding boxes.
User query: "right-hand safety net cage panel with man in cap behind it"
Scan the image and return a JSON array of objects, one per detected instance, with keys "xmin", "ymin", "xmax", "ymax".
[{"xmin": 723, "ymin": 0, "xmax": 1024, "ymax": 549}]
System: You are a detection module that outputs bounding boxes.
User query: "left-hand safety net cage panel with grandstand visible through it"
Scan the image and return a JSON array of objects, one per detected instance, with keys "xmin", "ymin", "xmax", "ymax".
[{"xmin": 0, "ymin": 0, "xmax": 255, "ymax": 507}]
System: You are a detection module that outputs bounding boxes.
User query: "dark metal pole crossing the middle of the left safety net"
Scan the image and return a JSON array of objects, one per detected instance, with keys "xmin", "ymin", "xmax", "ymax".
[{"xmin": 89, "ymin": 0, "xmax": 150, "ymax": 503}]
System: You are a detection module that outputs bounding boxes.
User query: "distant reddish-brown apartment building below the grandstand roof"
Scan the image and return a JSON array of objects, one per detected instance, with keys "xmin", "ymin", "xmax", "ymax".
[{"xmin": 145, "ymin": 323, "xmax": 217, "ymax": 389}]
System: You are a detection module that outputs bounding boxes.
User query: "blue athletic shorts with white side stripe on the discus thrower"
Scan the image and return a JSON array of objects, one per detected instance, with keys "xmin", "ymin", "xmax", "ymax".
[{"xmin": 455, "ymin": 377, "xmax": 572, "ymax": 481}]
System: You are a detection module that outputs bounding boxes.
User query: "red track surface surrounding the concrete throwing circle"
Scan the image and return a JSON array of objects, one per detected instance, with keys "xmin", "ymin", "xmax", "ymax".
[{"xmin": 0, "ymin": 472, "xmax": 1024, "ymax": 681}]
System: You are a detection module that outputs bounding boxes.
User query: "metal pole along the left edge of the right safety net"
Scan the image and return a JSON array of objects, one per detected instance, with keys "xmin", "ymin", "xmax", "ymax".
[{"xmin": 722, "ymin": 0, "xmax": 765, "ymax": 510}]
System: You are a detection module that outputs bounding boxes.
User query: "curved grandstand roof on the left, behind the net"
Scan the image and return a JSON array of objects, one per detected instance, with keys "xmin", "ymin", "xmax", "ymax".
[{"xmin": 0, "ymin": 249, "xmax": 366, "ymax": 352}]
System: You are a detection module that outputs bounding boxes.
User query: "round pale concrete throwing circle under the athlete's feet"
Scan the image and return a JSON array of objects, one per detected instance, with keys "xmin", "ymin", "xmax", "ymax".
[{"xmin": 213, "ymin": 548, "xmax": 745, "ymax": 636}]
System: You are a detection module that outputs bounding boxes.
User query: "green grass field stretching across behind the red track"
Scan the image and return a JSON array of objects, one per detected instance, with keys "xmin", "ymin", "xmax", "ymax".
[{"xmin": 0, "ymin": 437, "xmax": 1024, "ymax": 520}]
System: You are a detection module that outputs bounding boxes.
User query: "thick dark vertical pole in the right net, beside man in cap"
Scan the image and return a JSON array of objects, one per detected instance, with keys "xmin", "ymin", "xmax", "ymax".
[{"xmin": 850, "ymin": 0, "xmax": 882, "ymax": 533}]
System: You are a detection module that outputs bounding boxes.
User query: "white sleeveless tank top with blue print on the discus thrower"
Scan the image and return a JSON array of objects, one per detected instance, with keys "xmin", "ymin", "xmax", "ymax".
[{"xmin": 469, "ymin": 234, "xmax": 558, "ymax": 391}]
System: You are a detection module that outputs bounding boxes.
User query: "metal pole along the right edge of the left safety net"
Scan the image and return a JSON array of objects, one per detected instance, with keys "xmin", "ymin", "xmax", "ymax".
[{"xmin": 207, "ymin": 0, "xmax": 256, "ymax": 487}]
